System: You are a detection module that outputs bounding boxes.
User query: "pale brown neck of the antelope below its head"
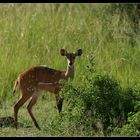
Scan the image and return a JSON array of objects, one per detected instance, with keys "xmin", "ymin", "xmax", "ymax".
[{"xmin": 65, "ymin": 65, "xmax": 74, "ymax": 79}]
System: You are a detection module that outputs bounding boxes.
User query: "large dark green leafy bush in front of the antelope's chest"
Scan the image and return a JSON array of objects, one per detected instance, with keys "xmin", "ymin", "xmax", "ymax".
[{"xmin": 48, "ymin": 56, "xmax": 138, "ymax": 136}]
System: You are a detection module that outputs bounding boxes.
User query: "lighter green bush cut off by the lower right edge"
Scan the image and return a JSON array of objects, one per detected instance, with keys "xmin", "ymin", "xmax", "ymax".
[{"xmin": 113, "ymin": 83, "xmax": 140, "ymax": 136}]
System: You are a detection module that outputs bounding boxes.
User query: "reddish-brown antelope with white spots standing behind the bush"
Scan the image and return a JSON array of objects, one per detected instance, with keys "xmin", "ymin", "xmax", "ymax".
[{"xmin": 13, "ymin": 49, "xmax": 82, "ymax": 130}]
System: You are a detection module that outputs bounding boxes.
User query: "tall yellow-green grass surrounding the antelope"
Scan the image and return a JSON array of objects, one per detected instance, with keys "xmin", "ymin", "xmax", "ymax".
[{"xmin": 0, "ymin": 4, "xmax": 140, "ymax": 136}]
